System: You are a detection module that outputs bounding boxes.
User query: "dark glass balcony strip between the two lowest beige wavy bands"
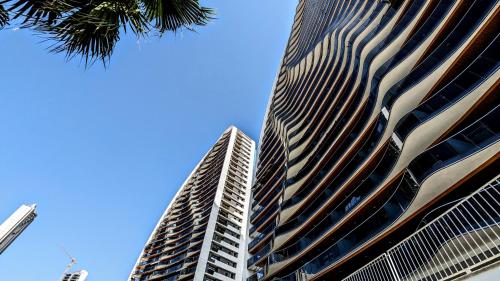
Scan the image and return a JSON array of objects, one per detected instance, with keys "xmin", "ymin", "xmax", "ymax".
[{"xmin": 274, "ymin": 106, "xmax": 500, "ymax": 280}]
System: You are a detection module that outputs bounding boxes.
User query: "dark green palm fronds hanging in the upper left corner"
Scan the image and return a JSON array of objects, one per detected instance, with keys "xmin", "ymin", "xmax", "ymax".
[{"xmin": 0, "ymin": 0, "xmax": 213, "ymax": 65}]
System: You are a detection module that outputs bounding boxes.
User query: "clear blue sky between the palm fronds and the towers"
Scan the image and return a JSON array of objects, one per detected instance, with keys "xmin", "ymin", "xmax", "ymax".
[{"xmin": 0, "ymin": 0, "xmax": 297, "ymax": 281}]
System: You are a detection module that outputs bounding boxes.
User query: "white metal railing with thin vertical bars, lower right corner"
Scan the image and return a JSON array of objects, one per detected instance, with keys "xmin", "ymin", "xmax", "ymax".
[{"xmin": 344, "ymin": 177, "xmax": 500, "ymax": 281}]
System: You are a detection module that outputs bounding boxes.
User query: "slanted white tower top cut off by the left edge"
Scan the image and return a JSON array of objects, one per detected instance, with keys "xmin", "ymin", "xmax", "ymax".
[{"xmin": 0, "ymin": 204, "xmax": 36, "ymax": 254}]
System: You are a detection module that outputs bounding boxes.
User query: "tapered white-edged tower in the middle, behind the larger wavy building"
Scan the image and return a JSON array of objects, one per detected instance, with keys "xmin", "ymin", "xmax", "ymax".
[{"xmin": 129, "ymin": 127, "xmax": 255, "ymax": 281}]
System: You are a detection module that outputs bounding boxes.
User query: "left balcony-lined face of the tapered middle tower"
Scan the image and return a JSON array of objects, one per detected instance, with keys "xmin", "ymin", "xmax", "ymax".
[{"xmin": 133, "ymin": 131, "xmax": 234, "ymax": 280}]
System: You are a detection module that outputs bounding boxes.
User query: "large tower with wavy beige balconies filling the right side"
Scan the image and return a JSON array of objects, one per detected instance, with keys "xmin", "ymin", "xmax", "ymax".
[{"xmin": 247, "ymin": 0, "xmax": 500, "ymax": 281}]
